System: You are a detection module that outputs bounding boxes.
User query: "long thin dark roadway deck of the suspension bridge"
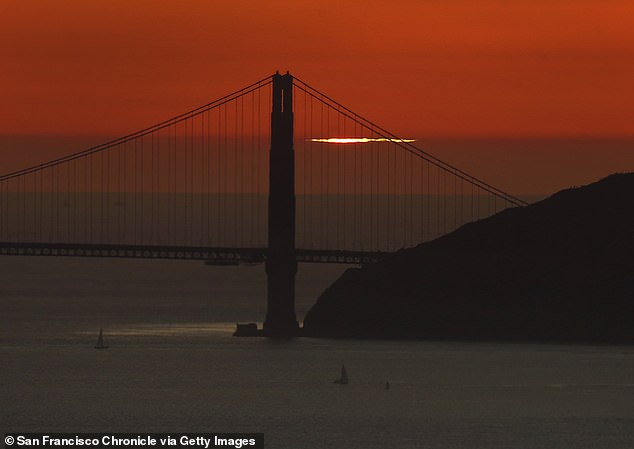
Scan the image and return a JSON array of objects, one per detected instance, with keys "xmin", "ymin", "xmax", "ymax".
[{"xmin": 0, "ymin": 242, "xmax": 390, "ymax": 265}]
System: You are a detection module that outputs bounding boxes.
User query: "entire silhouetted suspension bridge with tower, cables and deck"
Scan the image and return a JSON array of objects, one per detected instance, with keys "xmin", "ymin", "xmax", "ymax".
[{"xmin": 0, "ymin": 74, "xmax": 525, "ymax": 336}]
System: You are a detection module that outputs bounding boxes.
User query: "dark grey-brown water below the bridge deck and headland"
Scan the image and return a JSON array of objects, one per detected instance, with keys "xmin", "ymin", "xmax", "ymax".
[{"xmin": 0, "ymin": 257, "xmax": 634, "ymax": 449}]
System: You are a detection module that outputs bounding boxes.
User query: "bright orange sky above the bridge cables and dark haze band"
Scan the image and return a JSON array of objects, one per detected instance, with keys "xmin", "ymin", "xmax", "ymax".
[{"xmin": 0, "ymin": 0, "xmax": 634, "ymax": 192}]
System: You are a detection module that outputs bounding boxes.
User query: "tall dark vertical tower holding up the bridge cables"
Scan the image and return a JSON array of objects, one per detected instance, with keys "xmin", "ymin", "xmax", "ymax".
[{"xmin": 263, "ymin": 72, "xmax": 299, "ymax": 337}]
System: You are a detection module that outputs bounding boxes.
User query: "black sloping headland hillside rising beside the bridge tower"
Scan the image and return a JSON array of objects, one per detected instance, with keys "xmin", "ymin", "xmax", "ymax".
[{"xmin": 304, "ymin": 173, "xmax": 634, "ymax": 343}]
